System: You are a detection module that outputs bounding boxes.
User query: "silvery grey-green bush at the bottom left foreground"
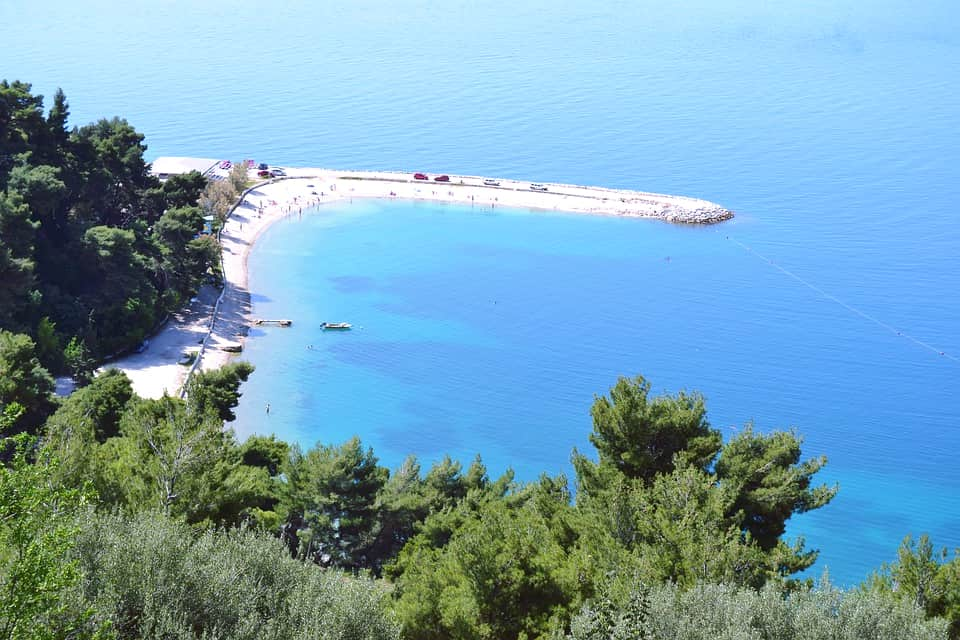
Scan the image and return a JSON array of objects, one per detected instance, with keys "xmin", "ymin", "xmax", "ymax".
[{"xmin": 69, "ymin": 513, "xmax": 398, "ymax": 640}]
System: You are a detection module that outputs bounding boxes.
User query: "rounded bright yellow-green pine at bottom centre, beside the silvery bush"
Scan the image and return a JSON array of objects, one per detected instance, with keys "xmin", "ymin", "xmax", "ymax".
[{"xmin": 392, "ymin": 478, "xmax": 588, "ymax": 640}]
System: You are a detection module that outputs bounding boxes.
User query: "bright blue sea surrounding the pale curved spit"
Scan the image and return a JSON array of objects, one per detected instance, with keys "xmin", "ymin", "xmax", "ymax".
[{"xmin": 9, "ymin": 0, "xmax": 960, "ymax": 585}]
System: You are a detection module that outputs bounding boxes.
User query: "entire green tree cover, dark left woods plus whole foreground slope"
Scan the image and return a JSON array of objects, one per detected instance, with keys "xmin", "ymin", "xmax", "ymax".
[{"xmin": 0, "ymin": 82, "xmax": 960, "ymax": 640}]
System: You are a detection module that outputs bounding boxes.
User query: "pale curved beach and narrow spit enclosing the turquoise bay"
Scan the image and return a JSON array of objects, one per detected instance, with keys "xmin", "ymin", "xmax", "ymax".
[{"xmin": 109, "ymin": 168, "xmax": 733, "ymax": 398}]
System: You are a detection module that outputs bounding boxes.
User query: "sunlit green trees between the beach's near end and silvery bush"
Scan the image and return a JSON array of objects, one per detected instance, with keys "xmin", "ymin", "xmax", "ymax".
[{"xmin": 44, "ymin": 363, "xmax": 287, "ymax": 528}]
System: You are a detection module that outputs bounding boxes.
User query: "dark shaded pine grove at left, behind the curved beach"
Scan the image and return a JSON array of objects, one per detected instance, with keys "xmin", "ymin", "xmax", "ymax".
[{"xmin": 0, "ymin": 81, "xmax": 217, "ymax": 364}]
